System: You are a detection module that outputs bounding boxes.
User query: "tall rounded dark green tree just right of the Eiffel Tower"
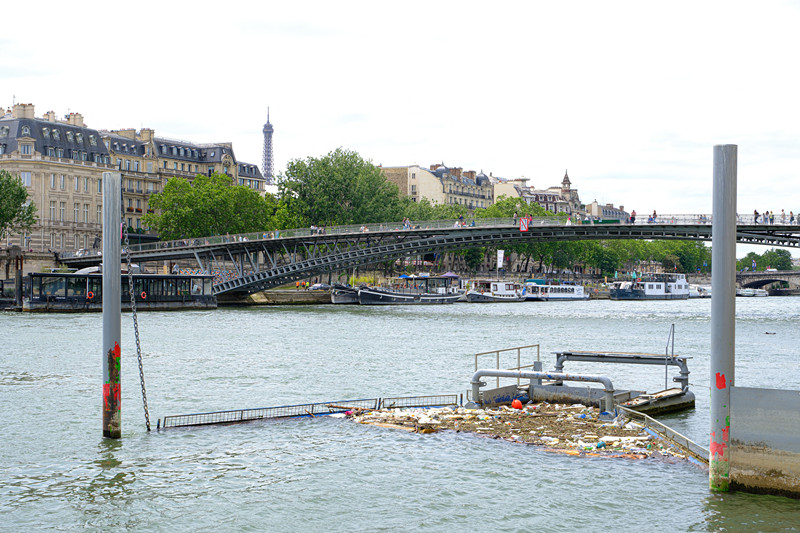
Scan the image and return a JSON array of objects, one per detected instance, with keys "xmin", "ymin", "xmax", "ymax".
[{"xmin": 280, "ymin": 148, "xmax": 402, "ymax": 227}]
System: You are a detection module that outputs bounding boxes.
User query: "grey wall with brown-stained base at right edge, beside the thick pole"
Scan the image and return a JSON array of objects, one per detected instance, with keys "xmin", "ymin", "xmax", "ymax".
[{"xmin": 729, "ymin": 387, "xmax": 800, "ymax": 498}]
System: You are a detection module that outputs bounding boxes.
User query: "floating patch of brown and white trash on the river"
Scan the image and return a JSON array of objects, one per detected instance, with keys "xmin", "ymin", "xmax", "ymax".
[{"xmin": 334, "ymin": 402, "xmax": 685, "ymax": 459}]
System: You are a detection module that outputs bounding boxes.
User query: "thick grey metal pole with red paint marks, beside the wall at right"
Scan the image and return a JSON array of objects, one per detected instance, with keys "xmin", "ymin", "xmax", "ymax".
[{"xmin": 708, "ymin": 144, "xmax": 737, "ymax": 492}]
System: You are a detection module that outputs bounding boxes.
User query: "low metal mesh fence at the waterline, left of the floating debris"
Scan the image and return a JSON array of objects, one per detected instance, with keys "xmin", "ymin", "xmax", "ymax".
[{"xmin": 158, "ymin": 394, "xmax": 458, "ymax": 429}]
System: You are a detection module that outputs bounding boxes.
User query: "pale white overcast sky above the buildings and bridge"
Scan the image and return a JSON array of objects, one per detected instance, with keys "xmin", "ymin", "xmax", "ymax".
[{"xmin": 0, "ymin": 0, "xmax": 800, "ymax": 255}]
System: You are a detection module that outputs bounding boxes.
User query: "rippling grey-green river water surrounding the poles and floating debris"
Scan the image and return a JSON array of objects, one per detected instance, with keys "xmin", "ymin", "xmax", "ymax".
[{"xmin": 0, "ymin": 297, "xmax": 800, "ymax": 532}]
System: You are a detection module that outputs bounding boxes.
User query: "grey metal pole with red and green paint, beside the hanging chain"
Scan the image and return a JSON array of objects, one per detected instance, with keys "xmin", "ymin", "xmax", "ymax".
[{"xmin": 103, "ymin": 172, "xmax": 122, "ymax": 439}]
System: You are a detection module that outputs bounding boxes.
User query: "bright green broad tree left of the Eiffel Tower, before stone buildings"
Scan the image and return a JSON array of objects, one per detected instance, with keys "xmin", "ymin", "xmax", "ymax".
[{"xmin": 143, "ymin": 174, "xmax": 275, "ymax": 239}]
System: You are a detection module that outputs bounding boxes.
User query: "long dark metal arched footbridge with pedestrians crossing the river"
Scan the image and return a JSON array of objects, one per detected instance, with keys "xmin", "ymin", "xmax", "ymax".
[{"xmin": 59, "ymin": 215, "xmax": 800, "ymax": 295}]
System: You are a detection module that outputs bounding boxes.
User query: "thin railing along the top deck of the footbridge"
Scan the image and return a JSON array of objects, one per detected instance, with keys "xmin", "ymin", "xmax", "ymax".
[{"xmin": 61, "ymin": 214, "xmax": 800, "ymax": 259}]
